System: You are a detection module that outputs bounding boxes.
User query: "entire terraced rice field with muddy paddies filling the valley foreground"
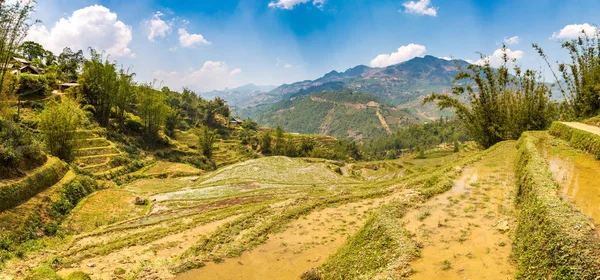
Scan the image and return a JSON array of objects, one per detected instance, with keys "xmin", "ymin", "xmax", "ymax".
[{"xmin": 0, "ymin": 123, "xmax": 600, "ymax": 279}]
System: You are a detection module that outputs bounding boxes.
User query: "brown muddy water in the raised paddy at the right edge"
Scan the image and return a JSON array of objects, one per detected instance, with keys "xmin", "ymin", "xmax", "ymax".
[{"xmin": 538, "ymin": 138, "xmax": 600, "ymax": 225}]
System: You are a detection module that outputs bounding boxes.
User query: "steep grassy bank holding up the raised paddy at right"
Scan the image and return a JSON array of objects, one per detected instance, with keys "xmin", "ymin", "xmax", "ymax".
[{"xmin": 514, "ymin": 132, "xmax": 600, "ymax": 279}]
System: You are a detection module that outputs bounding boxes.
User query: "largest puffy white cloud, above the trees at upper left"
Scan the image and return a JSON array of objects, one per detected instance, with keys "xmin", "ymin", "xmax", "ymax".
[{"xmin": 26, "ymin": 5, "xmax": 135, "ymax": 57}]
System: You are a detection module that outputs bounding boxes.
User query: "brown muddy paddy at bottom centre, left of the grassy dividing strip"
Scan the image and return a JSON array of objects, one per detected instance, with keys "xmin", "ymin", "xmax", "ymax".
[{"xmin": 175, "ymin": 191, "xmax": 412, "ymax": 280}]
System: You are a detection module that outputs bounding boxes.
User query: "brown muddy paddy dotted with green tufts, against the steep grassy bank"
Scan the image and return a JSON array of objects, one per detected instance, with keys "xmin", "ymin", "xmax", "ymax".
[{"xmin": 404, "ymin": 142, "xmax": 516, "ymax": 280}]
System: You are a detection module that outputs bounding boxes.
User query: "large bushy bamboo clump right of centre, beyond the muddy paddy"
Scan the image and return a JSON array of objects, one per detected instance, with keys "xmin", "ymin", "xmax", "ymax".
[{"xmin": 424, "ymin": 46, "xmax": 553, "ymax": 148}]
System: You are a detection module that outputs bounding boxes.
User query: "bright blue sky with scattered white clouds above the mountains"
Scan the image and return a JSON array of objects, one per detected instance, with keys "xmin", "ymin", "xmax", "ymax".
[{"xmin": 29, "ymin": 0, "xmax": 600, "ymax": 91}]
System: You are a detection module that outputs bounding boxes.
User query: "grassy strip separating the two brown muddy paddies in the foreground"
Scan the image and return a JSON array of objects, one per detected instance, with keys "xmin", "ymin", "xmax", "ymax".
[{"xmin": 321, "ymin": 143, "xmax": 502, "ymax": 279}]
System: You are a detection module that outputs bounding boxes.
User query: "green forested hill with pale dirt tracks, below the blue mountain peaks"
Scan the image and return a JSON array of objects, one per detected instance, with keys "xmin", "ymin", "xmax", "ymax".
[{"xmin": 238, "ymin": 89, "xmax": 418, "ymax": 141}]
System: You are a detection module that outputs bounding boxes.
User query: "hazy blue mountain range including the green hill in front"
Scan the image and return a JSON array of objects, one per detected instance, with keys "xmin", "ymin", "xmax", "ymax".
[{"xmin": 227, "ymin": 56, "xmax": 469, "ymax": 140}]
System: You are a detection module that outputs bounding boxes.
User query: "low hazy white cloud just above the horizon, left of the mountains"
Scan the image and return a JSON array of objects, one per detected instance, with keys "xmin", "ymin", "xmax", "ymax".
[{"xmin": 153, "ymin": 60, "xmax": 242, "ymax": 91}]
